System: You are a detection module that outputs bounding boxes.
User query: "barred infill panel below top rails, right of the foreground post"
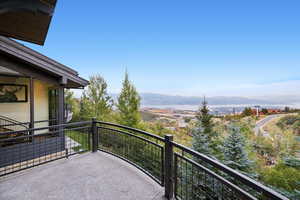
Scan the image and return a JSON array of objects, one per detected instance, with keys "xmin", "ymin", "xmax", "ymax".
[{"xmin": 174, "ymin": 153, "xmax": 256, "ymax": 200}]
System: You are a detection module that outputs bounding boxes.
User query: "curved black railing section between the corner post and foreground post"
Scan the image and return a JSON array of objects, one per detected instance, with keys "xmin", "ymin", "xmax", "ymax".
[{"xmin": 97, "ymin": 122, "xmax": 164, "ymax": 185}]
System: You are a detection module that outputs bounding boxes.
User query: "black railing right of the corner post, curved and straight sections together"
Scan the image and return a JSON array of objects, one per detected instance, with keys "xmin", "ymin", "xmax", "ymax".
[{"xmin": 96, "ymin": 121, "xmax": 288, "ymax": 200}]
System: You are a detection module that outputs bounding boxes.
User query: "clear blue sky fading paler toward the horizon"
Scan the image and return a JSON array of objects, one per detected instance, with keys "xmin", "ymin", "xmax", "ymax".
[{"xmin": 26, "ymin": 0, "xmax": 300, "ymax": 96}]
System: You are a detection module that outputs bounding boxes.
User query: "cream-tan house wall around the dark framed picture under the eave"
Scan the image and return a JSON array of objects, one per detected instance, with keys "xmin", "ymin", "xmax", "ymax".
[{"xmin": 0, "ymin": 76, "xmax": 50, "ymax": 127}]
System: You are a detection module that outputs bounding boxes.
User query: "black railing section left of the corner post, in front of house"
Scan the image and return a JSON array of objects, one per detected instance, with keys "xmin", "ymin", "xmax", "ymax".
[{"xmin": 0, "ymin": 122, "xmax": 91, "ymax": 176}]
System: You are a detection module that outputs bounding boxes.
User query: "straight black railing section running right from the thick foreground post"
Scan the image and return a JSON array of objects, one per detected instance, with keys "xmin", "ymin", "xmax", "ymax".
[{"xmin": 171, "ymin": 142, "xmax": 288, "ymax": 200}]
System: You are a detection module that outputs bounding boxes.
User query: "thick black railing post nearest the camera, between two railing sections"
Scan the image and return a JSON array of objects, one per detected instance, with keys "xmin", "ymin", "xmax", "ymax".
[{"xmin": 164, "ymin": 135, "xmax": 174, "ymax": 199}]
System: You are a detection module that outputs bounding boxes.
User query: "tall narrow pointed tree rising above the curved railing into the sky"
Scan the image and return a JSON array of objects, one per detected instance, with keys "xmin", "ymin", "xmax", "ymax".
[{"xmin": 117, "ymin": 72, "xmax": 141, "ymax": 128}]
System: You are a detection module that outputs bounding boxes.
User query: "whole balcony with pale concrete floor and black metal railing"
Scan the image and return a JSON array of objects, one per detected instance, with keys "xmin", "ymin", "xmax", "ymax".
[{"xmin": 0, "ymin": 120, "xmax": 287, "ymax": 200}]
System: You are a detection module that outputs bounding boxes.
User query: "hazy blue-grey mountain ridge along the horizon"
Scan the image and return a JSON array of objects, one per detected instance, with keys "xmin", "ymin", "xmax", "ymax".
[{"xmin": 112, "ymin": 93, "xmax": 300, "ymax": 105}]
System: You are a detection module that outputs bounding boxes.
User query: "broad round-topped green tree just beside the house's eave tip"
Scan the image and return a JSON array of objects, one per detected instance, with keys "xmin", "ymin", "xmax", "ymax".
[{"xmin": 81, "ymin": 75, "xmax": 113, "ymax": 121}]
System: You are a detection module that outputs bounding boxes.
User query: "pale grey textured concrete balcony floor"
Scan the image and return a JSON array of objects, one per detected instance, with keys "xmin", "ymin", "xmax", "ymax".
[{"xmin": 0, "ymin": 152, "xmax": 164, "ymax": 200}]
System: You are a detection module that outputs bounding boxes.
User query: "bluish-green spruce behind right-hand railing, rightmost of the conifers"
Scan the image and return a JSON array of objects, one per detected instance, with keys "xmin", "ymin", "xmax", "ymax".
[{"xmin": 224, "ymin": 125, "xmax": 251, "ymax": 172}]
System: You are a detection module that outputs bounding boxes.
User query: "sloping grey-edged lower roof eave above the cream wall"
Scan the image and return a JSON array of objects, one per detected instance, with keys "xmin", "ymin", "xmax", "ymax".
[{"xmin": 0, "ymin": 36, "xmax": 89, "ymax": 88}]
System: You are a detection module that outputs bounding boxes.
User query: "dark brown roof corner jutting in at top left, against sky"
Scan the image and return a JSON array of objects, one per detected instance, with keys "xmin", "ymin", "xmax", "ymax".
[{"xmin": 0, "ymin": 0, "xmax": 57, "ymax": 45}]
